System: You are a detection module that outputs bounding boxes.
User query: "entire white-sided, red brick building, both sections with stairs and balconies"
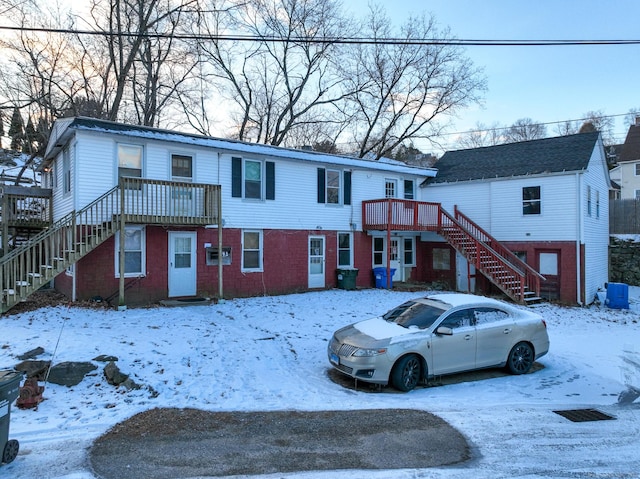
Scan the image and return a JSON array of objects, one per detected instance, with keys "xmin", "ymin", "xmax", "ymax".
[{"xmin": 0, "ymin": 117, "xmax": 608, "ymax": 311}]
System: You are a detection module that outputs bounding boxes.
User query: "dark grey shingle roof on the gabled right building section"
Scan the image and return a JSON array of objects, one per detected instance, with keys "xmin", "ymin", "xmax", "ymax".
[{"xmin": 426, "ymin": 131, "xmax": 600, "ymax": 184}]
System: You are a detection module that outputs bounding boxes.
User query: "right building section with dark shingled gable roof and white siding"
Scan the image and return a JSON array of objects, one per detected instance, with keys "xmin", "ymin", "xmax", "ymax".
[{"xmin": 422, "ymin": 132, "xmax": 610, "ymax": 304}]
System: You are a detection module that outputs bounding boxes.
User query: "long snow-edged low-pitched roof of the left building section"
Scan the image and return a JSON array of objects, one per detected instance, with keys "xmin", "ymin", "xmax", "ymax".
[{"xmin": 45, "ymin": 117, "xmax": 436, "ymax": 177}]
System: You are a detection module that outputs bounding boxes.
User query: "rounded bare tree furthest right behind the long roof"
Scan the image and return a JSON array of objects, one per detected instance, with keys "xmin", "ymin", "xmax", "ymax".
[{"xmin": 340, "ymin": 6, "xmax": 485, "ymax": 158}]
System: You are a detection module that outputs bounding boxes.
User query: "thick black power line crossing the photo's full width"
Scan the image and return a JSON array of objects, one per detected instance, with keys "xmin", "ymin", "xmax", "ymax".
[{"xmin": 0, "ymin": 25, "xmax": 640, "ymax": 47}]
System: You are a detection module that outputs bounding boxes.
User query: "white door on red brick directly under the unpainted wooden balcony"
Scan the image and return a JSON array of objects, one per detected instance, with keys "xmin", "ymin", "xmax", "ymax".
[{"xmin": 169, "ymin": 231, "xmax": 196, "ymax": 298}]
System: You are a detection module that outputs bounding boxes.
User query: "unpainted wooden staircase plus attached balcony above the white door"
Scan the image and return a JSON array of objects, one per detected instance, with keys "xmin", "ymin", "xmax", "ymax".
[{"xmin": 0, "ymin": 177, "xmax": 222, "ymax": 313}]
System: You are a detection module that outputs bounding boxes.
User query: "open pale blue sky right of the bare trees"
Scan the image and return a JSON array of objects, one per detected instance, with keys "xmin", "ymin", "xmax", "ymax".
[{"xmin": 344, "ymin": 0, "xmax": 640, "ymax": 151}]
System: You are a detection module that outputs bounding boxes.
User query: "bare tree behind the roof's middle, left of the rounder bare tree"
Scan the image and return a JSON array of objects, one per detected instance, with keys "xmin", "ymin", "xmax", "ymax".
[{"xmin": 195, "ymin": 0, "xmax": 350, "ymax": 145}]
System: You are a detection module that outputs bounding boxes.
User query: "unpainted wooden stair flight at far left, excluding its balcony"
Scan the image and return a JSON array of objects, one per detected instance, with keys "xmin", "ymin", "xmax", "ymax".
[{"xmin": 0, "ymin": 186, "xmax": 120, "ymax": 313}]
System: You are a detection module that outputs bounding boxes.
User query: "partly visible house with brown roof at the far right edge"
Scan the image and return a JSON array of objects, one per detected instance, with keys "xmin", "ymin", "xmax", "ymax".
[{"xmin": 610, "ymin": 121, "xmax": 640, "ymax": 200}]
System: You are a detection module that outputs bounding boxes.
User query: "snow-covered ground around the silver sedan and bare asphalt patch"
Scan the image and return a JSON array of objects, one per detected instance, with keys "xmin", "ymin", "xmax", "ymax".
[{"xmin": 0, "ymin": 287, "xmax": 640, "ymax": 479}]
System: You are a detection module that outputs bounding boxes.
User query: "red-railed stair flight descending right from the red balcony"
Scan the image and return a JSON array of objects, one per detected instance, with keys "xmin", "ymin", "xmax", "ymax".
[{"xmin": 439, "ymin": 208, "xmax": 545, "ymax": 305}]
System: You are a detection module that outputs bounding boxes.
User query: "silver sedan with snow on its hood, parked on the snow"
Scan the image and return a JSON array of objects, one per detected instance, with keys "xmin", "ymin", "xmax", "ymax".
[{"xmin": 328, "ymin": 293, "xmax": 549, "ymax": 391}]
